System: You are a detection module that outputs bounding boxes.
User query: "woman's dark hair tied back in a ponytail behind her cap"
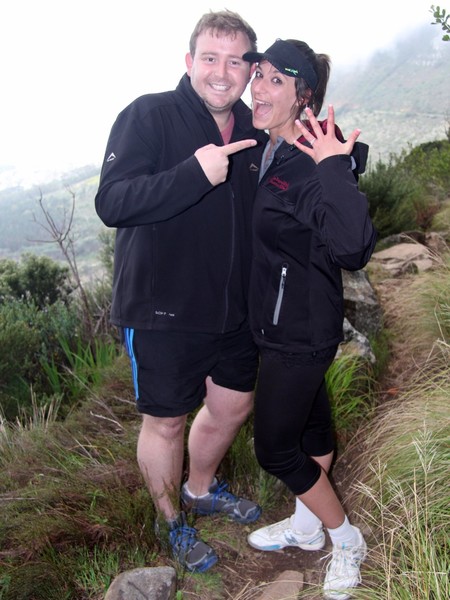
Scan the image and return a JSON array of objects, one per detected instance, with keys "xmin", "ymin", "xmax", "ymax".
[{"xmin": 286, "ymin": 40, "xmax": 331, "ymax": 119}]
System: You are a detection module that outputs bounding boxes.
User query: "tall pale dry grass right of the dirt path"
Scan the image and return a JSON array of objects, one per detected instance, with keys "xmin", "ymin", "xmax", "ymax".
[{"xmin": 347, "ymin": 261, "xmax": 450, "ymax": 600}]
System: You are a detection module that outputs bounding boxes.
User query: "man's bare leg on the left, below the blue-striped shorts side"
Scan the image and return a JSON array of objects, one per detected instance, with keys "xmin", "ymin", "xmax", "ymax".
[{"xmin": 137, "ymin": 415, "xmax": 186, "ymax": 520}]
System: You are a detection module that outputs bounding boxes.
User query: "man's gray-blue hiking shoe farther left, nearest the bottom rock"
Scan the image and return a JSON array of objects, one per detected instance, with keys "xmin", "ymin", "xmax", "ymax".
[{"xmin": 155, "ymin": 512, "xmax": 217, "ymax": 573}]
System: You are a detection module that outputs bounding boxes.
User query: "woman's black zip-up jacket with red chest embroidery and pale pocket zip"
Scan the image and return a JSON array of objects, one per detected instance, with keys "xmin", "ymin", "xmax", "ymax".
[{"xmin": 250, "ymin": 142, "xmax": 377, "ymax": 353}]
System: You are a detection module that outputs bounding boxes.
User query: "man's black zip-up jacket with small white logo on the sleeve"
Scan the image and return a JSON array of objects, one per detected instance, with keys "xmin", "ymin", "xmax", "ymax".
[{"xmin": 95, "ymin": 75, "xmax": 266, "ymax": 333}]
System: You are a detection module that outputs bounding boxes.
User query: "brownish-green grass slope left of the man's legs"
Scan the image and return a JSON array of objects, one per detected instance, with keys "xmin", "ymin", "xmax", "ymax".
[{"xmin": 0, "ymin": 364, "xmax": 159, "ymax": 600}]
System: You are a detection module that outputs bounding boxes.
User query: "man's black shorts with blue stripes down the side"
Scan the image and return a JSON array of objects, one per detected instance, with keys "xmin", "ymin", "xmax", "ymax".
[{"xmin": 122, "ymin": 328, "xmax": 258, "ymax": 417}]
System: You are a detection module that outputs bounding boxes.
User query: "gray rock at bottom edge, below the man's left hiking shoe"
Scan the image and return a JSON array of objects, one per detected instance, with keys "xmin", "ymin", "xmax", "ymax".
[{"xmin": 105, "ymin": 567, "xmax": 177, "ymax": 600}]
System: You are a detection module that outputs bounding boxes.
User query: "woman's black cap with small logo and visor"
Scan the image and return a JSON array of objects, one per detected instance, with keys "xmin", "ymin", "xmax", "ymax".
[{"xmin": 242, "ymin": 40, "xmax": 318, "ymax": 90}]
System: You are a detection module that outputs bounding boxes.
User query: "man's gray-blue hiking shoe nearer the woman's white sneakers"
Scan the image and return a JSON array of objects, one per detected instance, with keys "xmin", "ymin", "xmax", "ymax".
[{"xmin": 181, "ymin": 480, "xmax": 261, "ymax": 523}]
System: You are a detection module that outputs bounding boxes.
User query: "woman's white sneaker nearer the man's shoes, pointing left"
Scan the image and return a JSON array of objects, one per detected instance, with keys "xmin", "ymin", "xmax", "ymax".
[{"xmin": 247, "ymin": 516, "xmax": 325, "ymax": 552}]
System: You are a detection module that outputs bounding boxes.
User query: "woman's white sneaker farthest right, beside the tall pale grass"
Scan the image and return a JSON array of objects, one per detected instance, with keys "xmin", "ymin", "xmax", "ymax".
[{"xmin": 323, "ymin": 526, "xmax": 367, "ymax": 600}]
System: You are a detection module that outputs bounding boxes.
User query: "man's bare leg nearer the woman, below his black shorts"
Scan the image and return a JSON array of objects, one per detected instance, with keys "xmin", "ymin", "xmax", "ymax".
[{"xmin": 187, "ymin": 377, "xmax": 253, "ymax": 496}]
